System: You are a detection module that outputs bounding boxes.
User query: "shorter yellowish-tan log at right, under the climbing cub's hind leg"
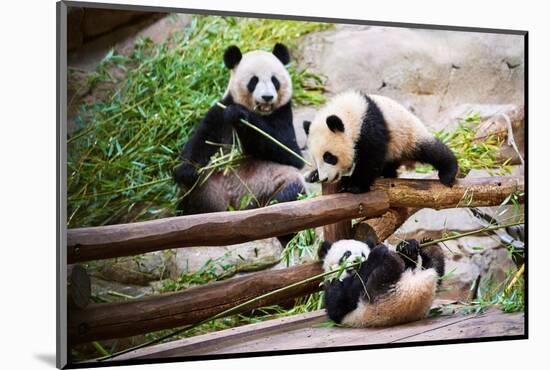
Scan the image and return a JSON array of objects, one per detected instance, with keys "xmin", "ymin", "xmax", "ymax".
[{"xmin": 372, "ymin": 176, "xmax": 525, "ymax": 209}]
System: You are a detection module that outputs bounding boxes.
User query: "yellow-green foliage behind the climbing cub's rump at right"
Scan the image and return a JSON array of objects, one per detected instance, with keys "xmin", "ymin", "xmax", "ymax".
[{"xmin": 416, "ymin": 113, "xmax": 511, "ymax": 175}]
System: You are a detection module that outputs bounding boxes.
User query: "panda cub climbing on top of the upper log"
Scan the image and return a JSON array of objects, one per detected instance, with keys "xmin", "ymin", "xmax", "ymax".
[{"xmin": 303, "ymin": 91, "xmax": 458, "ymax": 193}]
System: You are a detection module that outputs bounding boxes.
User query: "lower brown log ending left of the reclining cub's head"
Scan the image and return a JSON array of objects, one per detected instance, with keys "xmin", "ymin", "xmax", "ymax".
[{"xmin": 68, "ymin": 262, "xmax": 323, "ymax": 344}]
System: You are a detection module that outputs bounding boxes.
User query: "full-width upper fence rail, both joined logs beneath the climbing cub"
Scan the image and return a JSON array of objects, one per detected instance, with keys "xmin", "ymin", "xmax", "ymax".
[{"xmin": 67, "ymin": 177, "xmax": 524, "ymax": 263}]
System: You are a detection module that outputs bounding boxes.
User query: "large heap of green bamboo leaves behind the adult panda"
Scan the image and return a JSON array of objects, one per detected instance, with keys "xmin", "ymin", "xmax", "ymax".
[{"xmin": 67, "ymin": 16, "xmax": 330, "ymax": 227}]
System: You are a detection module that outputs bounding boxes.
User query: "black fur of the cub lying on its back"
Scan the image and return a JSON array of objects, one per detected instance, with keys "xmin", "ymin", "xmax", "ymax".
[{"xmin": 318, "ymin": 239, "xmax": 445, "ymax": 323}]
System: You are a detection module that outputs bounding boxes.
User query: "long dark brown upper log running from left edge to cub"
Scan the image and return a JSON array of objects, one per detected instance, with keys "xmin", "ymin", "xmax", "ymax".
[{"xmin": 67, "ymin": 191, "xmax": 389, "ymax": 263}]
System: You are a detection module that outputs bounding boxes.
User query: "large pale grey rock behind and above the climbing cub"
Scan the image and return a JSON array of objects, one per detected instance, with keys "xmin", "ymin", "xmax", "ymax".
[{"xmin": 297, "ymin": 25, "xmax": 524, "ymax": 130}]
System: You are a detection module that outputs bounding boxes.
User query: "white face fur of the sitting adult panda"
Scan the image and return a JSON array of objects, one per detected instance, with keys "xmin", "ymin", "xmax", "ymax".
[{"xmin": 225, "ymin": 50, "xmax": 292, "ymax": 114}]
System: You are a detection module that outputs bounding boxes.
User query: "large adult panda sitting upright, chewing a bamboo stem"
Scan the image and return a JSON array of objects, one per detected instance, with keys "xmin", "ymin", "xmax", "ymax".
[{"xmin": 174, "ymin": 44, "xmax": 305, "ymax": 220}]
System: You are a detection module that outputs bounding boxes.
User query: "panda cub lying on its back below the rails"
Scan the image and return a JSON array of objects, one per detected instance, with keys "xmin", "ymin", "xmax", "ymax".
[{"xmin": 319, "ymin": 239, "xmax": 445, "ymax": 327}]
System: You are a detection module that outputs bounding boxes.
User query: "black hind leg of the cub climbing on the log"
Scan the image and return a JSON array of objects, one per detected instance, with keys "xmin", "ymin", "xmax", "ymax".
[{"xmin": 413, "ymin": 138, "xmax": 458, "ymax": 186}]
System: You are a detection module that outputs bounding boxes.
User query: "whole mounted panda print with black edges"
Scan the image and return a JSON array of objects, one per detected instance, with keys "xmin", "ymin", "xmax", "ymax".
[{"xmin": 57, "ymin": 1, "xmax": 528, "ymax": 368}]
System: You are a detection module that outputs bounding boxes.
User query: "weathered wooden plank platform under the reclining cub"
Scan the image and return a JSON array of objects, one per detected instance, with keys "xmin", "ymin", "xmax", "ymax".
[{"xmin": 114, "ymin": 308, "xmax": 524, "ymax": 360}]
